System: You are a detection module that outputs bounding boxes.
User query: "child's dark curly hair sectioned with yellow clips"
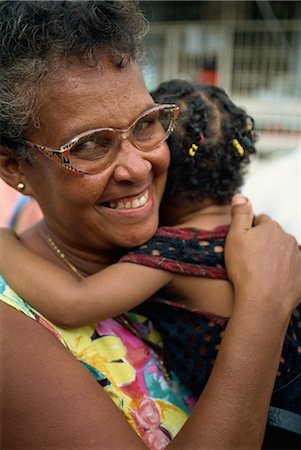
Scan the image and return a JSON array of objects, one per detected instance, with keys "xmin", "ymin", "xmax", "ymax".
[{"xmin": 151, "ymin": 79, "xmax": 256, "ymax": 204}]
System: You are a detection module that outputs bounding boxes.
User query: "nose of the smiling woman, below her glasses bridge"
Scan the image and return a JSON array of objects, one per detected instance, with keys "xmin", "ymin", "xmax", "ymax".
[{"xmin": 114, "ymin": 139, "xmax": 152, "ymax": 183}]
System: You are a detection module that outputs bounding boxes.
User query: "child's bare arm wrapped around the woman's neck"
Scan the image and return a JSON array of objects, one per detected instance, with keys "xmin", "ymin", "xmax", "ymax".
[{"xmin": 0, "ymin": 230, "xmax": 172, "ymax": 327}]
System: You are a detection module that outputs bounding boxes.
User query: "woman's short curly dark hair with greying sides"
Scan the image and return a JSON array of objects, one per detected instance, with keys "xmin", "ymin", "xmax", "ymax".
[{"xmin": 0, "ymin": 0, "xmax": 147, "ymax": 159}]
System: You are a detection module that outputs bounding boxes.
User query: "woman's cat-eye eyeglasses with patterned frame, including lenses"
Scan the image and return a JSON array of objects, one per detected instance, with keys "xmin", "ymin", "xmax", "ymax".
[{"xmin": 23, "ymin": 104, "xmax": 179, "ymax": 174}]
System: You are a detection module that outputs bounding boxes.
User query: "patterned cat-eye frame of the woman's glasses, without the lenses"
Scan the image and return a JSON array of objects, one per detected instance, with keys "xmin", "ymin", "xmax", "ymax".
[{"xmin": 22, "ymin": 103, "xmax": 180, "ymax": 175}]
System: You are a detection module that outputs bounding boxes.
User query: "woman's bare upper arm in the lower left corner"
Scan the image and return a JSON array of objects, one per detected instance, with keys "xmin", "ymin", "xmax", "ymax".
[{"xmin": 0, "ymin": 298, "xmax": 143, "ymax": 448}]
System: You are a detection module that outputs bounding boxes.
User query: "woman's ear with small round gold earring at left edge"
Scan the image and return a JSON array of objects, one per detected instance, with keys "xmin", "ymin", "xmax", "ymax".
[{"xmin": 0, "ymin": 144, "xmax": 33, "ymax": 195}]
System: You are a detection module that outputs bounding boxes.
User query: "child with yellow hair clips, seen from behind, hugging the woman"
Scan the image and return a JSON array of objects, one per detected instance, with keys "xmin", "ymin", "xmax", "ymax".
[{"xmin": 0, "ymin": 80, "xmax": 301, "ymax": 412}]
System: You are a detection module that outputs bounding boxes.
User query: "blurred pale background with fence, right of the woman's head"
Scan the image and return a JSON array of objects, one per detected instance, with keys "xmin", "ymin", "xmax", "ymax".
[{"xmin": 140, "ymin": 0, "xmax": 301, "ymax": 242}]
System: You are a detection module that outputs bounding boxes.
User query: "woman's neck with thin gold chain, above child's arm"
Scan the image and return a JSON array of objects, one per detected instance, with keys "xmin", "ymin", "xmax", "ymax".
[{"xmin": 20, "ymin": 220, "xmax": 123, "ymax": 275}]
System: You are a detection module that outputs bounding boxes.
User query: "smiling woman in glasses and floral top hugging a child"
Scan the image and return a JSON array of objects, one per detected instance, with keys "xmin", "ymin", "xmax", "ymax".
[{"xmin": 0, "ymin": 2, "xmax": 301, "ymax": 449}]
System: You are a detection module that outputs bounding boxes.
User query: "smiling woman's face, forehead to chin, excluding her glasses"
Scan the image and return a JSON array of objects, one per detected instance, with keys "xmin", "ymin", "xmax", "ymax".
[{"xmin": 22, "ymin": 61, "xmax": 169, "ymax": 251}]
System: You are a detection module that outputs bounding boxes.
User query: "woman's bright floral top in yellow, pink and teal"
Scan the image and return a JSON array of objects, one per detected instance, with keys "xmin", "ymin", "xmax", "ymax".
[{"xmin": 0, "ymin": 276, "xmax": 195, "ymax": 450}]
